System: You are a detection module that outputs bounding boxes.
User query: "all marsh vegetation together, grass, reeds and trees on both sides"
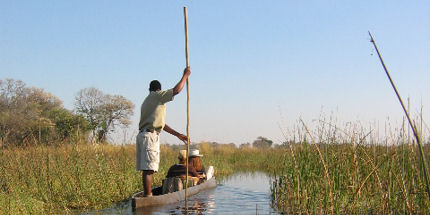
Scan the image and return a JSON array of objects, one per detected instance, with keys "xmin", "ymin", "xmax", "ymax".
[{"xmin": 0, "ymin": 80, "xmax": 430, "ymax": 214}]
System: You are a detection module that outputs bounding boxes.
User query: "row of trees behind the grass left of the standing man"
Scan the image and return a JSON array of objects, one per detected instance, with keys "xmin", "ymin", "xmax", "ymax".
[{"xmin": 0, "ymin": 79, "xmax": 134, "ymax": 147}]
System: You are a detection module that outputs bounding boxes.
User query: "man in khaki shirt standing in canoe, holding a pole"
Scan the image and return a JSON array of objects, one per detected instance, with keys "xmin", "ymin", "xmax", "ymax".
[{"xmin": 136, "ymin": 67, "xmax": 191, "ymax": 196}]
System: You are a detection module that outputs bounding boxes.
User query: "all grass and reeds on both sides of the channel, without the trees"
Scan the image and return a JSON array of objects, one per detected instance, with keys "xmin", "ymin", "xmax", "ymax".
[{"xmin": 0, "ymin": 123, "xmax": 430, "ymax": 214}]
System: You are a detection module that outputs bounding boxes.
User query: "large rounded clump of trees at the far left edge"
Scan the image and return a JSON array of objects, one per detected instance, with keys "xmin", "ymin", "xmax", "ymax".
[{"xmin": 0, "ymin": 79, "xmax": 86, "ymax": 146}]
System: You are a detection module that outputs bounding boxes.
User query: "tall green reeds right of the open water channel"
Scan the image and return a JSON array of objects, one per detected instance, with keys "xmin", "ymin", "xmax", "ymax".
[{"xmin": 271, "ymin": 122, "xmax": 430, "ymax": 214}]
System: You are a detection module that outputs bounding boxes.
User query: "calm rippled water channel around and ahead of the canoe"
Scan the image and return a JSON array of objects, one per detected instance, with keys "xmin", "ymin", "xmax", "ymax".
[{"xmin": 80, "ymin": 173, "xmax": 276, "ymax": 215}]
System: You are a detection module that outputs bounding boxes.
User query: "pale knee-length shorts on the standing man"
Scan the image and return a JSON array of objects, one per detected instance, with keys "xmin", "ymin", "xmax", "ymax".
[{"xmin": 136, "ymin": 131, "xmax": 160, "ymax": 172}]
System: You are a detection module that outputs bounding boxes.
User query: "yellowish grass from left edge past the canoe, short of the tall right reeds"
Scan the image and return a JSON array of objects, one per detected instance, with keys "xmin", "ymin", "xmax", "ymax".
[{"xmin": 0, "ymin": 143, "xmax": 284, "ymax": 214}]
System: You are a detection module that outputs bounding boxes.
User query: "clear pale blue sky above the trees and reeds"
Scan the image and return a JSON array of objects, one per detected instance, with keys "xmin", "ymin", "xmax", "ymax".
[{"xmin": 0, "ymin": 0, "xmax": 430, "ymax": 144}]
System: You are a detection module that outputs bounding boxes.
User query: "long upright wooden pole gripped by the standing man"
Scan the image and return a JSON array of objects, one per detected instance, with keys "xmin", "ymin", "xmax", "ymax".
[{"xmin": 184, "ymin": 7, "xmax": 190, "ymax": 208}]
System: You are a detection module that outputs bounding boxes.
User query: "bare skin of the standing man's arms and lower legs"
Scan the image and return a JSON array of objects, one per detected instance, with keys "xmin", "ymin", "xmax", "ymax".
[{"xmin": 142, "ymin": 67, "xmax": 191, "ymax": 196}]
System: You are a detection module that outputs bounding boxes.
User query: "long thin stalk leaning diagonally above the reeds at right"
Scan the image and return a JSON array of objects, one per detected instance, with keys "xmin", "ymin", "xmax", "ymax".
[{"xmin": 369, "ymin": 31, "xmax": 430, "ymax": 198}]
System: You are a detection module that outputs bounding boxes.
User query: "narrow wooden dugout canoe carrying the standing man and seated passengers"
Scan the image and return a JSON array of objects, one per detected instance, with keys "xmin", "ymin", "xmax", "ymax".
[{"xmin": 131, "ymin": 177, "xmax": 216, "ymax": 209}]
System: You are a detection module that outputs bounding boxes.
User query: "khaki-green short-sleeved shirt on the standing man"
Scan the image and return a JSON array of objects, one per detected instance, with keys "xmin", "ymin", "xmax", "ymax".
[{"xmin": 139, "ymin": 89, "xmax": 173, "ymax": 133}]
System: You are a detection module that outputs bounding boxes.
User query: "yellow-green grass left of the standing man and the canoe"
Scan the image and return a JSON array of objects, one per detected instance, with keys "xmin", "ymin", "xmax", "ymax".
[{"xmin": 0, "ymin": 145, "xmax": 139, "ymax": 214}]
